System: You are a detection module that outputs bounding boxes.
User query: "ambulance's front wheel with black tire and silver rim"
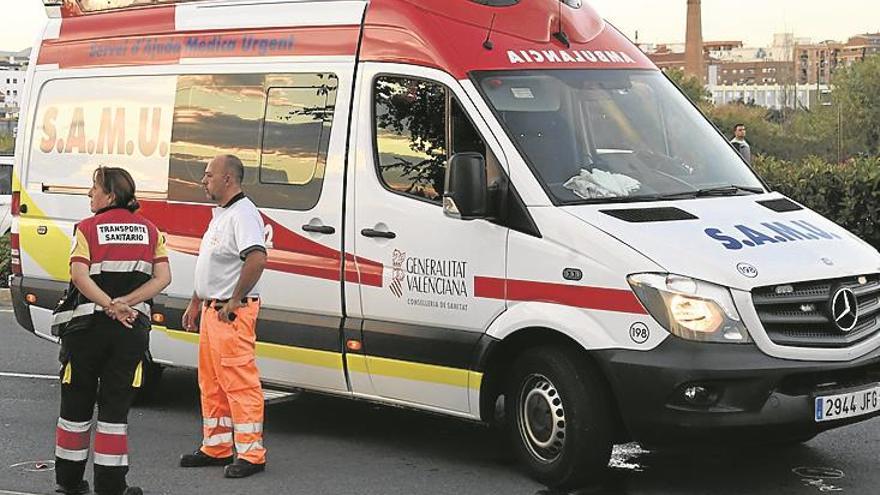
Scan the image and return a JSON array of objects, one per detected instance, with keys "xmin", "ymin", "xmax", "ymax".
[{"xmin": 505, "ymin": 346, "xmax": 613, "ymax": 489}]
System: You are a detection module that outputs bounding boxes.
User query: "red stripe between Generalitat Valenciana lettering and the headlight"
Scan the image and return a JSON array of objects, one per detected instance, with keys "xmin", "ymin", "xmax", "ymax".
[{"xmin": 474, "ymin": 277, "xmax": 648, "ymax": 315}]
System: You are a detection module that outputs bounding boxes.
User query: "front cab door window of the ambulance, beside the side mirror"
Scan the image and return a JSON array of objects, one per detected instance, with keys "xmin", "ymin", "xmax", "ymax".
[{"xmin": 373, "ymin": 76, "xmax": 501, "ymax": 205}]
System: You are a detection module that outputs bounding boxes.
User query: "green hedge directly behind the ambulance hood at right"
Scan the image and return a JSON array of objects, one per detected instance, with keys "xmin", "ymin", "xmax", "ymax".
[{"xmin": 755, "ymin": 156, "xmax": 880, "ymax": 248}]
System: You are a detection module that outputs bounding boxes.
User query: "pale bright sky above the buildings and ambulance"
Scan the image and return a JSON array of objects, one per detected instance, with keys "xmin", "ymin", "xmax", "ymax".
[{"xmin": 0, "ymin": 0, "xmax": 880, "ymax": 51}]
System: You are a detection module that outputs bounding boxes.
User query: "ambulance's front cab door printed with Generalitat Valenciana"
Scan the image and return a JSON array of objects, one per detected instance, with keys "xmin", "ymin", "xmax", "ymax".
[{"xmin": 348, "ymin": 64, "xmax": 508, "ymax": 415}]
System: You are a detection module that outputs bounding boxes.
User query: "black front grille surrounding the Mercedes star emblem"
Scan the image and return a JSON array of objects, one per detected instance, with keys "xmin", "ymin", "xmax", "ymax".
[{"xmin": 752, "ymin": 274, "xmax": 880, "ymax": 348}]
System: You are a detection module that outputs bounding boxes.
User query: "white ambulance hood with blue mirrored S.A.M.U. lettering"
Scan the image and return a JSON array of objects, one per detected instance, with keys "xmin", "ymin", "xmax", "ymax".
[{"xmin": 562, "ymin": 193, "xmax": 880, "ymax": 290}]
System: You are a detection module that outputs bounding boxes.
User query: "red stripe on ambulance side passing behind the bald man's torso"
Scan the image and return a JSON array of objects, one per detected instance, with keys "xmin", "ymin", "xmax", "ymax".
[{"xmin": 140, "ymin": 201, "xmax": 383, "ymax": 287}]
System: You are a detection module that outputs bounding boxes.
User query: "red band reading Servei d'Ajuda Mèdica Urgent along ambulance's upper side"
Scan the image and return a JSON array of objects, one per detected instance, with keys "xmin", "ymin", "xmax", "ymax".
[{"xmin": 37, "ymin": 25, "xmax": 360, "ymax": 68}]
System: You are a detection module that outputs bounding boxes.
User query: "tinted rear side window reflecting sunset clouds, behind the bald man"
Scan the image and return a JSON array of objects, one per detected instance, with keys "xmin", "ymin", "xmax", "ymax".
[{"xmin": 168, "ymin": 74, "xmax": 337, "ymax": 210}]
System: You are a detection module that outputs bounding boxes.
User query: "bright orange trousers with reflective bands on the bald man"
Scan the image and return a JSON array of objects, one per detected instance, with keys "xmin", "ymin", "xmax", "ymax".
[{"xmin": 199, "ymin": 301, "xmax": 266, "ymax": 464}]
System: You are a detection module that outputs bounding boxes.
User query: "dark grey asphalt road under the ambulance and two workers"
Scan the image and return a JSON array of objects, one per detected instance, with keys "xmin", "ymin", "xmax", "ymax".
[{"xmin": 0, "ymin": 308, "xmax": 880, "ymax": 495}]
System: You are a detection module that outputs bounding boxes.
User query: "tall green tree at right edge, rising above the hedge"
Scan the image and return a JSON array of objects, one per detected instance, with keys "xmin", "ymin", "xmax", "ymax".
[{"xmin": 833, "ymin": 55, "xmax": 880, "ymax": 156}]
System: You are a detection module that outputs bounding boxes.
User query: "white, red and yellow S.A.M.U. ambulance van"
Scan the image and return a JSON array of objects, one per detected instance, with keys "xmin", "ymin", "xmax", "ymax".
[{"xmin": 11, "ymin": 0, "xmax": 880, "ymax": 487}]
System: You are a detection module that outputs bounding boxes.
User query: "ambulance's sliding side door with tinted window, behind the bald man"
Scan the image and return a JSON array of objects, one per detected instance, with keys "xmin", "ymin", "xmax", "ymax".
[{"xmin": 165, "ymin": 69, "xmax": 351, "ymax": 392}]
